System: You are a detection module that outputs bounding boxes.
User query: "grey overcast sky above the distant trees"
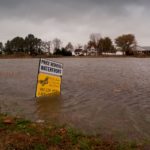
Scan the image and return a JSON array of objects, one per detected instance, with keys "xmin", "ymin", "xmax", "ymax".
[{"xmin": 0, "ymin": 0, "xmax": 150, "ymax": 46}]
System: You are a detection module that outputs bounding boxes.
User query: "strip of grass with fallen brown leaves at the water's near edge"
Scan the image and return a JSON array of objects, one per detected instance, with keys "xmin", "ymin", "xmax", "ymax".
[{"xmin": 0, "ymin": 114, "xmax": 150, "ymax": 150}]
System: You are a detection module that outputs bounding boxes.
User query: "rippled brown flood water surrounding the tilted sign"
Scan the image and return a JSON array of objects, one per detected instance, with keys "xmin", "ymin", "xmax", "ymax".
[{"xmin": 0, "ymin": 58, "xmax": 150, "ymax": 139}]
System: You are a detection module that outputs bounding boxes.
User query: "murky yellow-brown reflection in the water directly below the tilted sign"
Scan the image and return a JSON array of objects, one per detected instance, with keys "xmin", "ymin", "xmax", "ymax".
[{"xmin": 36, "ymin": 95, "xmax": 62, "ymax": 121}]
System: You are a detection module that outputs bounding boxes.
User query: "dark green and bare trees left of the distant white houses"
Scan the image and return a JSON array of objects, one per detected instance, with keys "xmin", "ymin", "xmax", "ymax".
[{"xmin": 0, "ymin": 34, "xmax": 72, "ymax": 56}]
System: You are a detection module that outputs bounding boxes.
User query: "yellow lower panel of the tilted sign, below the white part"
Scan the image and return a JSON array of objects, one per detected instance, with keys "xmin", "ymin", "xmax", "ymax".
[{"xmin": 36, "ymin": 73, "xmax": 61, "ymax": 97}]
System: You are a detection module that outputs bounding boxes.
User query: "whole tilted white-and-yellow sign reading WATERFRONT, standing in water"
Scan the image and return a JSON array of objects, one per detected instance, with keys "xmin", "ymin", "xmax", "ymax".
[{"xmin": 36, "ymin": 59, "xmax": 63, "ymax": 97}]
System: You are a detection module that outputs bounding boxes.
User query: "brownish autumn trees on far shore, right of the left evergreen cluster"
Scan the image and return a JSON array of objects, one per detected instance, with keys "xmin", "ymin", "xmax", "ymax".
[{"xmin": 87, "ymin": 34, "xmax": 136, "ymax": 55}]
